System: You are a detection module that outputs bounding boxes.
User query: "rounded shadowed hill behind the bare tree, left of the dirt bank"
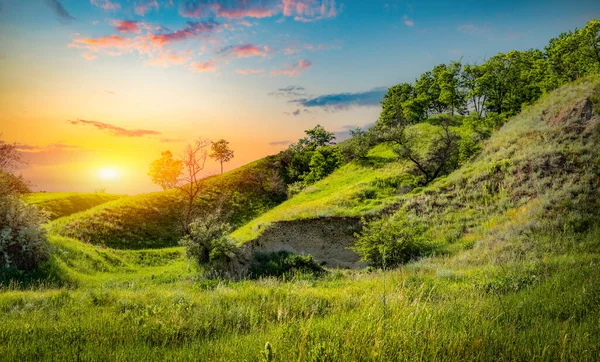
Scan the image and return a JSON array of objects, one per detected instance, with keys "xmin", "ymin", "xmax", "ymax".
[{"xmin": 49, "ymin": 159, "xmax": 288, "ymax": 249}]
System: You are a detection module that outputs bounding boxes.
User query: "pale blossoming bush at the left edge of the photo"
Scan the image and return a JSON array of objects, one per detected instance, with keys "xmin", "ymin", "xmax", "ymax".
[{"xmin": 0, "ymin": 195, "xmax": 50, "ymax": 270}]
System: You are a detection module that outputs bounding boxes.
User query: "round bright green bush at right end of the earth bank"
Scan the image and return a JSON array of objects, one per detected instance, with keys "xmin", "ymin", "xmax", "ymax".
[{"xmin": 352, "ymin": 212, "xmax": 430, "ymax": 268}]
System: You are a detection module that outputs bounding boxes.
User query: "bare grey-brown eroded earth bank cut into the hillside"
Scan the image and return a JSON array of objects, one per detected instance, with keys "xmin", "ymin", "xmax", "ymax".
[{"xmin": 238, "ymin": 217, "xmax": 366, "ymax": 269}]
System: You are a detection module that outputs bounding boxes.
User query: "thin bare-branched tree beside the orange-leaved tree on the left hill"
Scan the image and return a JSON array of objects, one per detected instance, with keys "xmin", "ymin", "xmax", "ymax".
[{"xmin": 177, "ymin": 139, "xmax": 211, "ymax": 234}]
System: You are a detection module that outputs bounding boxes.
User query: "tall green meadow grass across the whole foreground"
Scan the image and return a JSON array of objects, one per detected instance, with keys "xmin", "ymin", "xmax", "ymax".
[{"xmin": 0, "ymin": 228, "xmax": 600, "ymax": 361}]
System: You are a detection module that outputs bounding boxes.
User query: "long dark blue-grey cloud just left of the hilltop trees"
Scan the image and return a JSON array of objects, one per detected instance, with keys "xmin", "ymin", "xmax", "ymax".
[{"xmin": 290, "ymin": 88, "xmax": 387, "ymax": 111}]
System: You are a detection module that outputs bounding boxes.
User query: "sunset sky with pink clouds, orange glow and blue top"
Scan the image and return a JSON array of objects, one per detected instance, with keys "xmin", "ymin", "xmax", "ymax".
[{"xmin": 0, "ymin": 0, "xmax": 600, "ymax": 194}]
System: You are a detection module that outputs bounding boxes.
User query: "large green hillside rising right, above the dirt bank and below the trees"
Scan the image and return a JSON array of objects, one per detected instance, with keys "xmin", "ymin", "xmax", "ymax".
[{"xmin": 234, "ymin": 78, "xmax": 600, "ymax": 256}]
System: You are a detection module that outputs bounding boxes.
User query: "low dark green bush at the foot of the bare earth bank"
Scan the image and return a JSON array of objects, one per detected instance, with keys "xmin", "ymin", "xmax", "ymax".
[{"xmin": 248, "ymin": 251, "xmax": 326, "ymax": 278}]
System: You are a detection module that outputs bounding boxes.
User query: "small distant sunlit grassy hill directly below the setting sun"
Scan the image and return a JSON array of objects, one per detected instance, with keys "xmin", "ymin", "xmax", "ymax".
[{"xmin": 24, "ymin": 192, "xmax": 124, "ymax": 220}]
